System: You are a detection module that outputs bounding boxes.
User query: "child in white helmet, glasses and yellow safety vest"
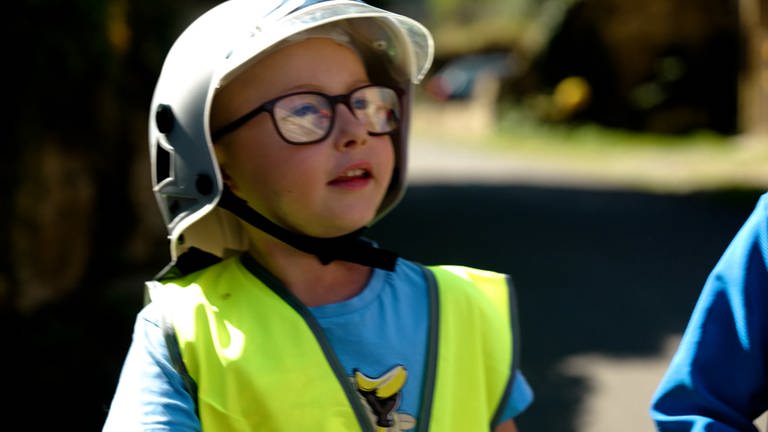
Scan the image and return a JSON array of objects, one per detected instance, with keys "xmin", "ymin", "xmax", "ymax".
[{"xmin": 104, "ymin": 0, "xmax": 533, "ymax": 431}]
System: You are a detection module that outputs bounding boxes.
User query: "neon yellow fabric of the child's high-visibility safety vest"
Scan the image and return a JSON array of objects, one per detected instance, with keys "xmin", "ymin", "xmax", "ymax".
[{"xmin": 152, "ymin": 255, "xmax": 516, "ymax": 432}]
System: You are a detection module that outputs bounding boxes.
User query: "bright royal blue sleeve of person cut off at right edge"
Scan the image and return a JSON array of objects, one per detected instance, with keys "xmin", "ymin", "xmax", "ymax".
[{"xmin": 650, "ymin": 195, "xmax": 768, "ymax": 432}]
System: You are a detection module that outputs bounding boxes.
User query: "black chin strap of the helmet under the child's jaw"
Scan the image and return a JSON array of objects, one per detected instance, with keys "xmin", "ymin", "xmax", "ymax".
[{"xmin": 218, "ymin": 187, "xmax": 397, "ymax": 271}]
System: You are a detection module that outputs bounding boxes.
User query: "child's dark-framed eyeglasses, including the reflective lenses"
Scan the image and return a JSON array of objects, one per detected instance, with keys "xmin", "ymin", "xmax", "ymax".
[{"xmin": 211, "ymin": 84, "xmax": 400, "ymax": 145}]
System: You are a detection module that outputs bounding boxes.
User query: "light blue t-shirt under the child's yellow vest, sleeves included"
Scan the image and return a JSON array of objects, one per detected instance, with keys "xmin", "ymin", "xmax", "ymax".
[{"xmin": 104, "ymin": 259, "xmax": 533, "ymax": 431}]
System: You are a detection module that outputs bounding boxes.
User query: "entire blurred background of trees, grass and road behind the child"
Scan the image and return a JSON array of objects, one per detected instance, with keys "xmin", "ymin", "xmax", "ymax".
[{"xmin": 0, "ymin": 0, "xmax": 768, "ymax": 432}]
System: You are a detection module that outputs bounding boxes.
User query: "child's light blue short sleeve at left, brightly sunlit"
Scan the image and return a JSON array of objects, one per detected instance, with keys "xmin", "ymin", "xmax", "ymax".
[{"xmin": 103, "ymin": 303, "xmax": 200, "ymax": 432}]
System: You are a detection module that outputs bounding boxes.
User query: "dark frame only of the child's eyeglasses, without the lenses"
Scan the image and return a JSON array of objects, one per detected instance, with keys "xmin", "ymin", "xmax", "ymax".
[{"xmin": 211, "ymin": 84, "xmax": 403, "ymax": 145}]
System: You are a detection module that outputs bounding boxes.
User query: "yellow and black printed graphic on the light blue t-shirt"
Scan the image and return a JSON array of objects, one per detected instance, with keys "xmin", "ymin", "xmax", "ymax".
[{"xmin": 353, "ymin": 366, "xmax": 416, "ymax": 432}]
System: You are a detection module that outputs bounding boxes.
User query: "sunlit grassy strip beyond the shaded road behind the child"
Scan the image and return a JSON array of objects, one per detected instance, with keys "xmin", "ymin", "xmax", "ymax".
[{"xmin": 414, "ymin": 101, "xmax": 768, "ymax": 192}]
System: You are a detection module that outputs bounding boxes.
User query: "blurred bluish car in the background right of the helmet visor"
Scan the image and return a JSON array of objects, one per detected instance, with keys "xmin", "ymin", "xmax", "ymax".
[{"xmin": 426, "ymin": 52, "xmax": 514, "ymax": 101}]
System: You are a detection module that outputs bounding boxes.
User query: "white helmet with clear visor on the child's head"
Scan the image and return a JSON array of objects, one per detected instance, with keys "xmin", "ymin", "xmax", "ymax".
[{"xmin": 149, "ymin": 0, "xmax": 433, "ymax": 260}]
